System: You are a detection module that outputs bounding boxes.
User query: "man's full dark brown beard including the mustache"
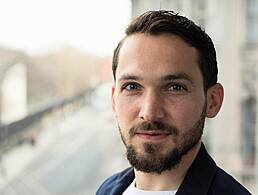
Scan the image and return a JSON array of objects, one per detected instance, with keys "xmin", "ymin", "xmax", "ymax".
[{"xmin": 119, "ymin": 106, "xmax": 206, "ymax": 174}]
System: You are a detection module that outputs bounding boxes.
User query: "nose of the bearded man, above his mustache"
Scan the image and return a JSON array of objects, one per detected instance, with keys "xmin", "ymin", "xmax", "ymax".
[{"xmin": 139, "ymin": 92, "xmax": 165, "ymax": 121}]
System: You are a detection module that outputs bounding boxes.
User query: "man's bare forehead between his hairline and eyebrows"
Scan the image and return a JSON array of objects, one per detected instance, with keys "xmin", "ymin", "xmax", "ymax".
[{"xmin": 116, "ymin": 34, "xmax": 201, "ymax": 84}]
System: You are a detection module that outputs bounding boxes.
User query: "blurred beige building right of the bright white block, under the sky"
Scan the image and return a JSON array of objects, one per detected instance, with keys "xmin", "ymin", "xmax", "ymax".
[{"xmin": 28, "ymin": 46, "xmax": 101, "ymax": 110}]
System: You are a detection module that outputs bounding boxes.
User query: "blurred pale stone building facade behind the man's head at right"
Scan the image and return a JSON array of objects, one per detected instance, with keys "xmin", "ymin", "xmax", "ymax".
[{"xmin": 132, "ymin": 0, "xmax": 258, "ymax": 192}]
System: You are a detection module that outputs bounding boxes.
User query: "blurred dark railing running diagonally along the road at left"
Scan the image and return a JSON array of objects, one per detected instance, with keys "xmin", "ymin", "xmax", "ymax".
[{"xmin": 0, "ymin": 89, "xmax": 92, "ymax": 157}]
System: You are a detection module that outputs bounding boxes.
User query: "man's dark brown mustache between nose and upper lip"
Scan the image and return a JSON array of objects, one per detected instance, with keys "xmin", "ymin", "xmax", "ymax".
[{"xmin": 129, "ymin": 121, "xmax": 178, "ymax": 137}]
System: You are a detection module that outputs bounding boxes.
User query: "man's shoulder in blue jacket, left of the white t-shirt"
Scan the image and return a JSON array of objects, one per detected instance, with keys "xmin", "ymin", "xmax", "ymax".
[{"xmin": 96, "ymin": 167, "xmax": 134, "ymax": 195}]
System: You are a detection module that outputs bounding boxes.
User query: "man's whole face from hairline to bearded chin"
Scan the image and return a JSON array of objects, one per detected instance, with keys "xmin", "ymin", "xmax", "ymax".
[{"xmin": 112, "ymin": 34, "xmax": 206, "ymax": 173}]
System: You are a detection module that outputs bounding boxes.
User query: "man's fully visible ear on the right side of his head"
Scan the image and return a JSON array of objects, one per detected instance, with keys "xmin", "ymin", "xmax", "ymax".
[{"xmin": 206, "ymin": 83, "xmax": 224, "ymax": 118}]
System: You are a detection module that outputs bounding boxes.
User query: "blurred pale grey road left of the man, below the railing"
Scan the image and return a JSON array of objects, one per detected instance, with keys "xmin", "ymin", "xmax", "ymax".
[{"xmin": 0, "ymin": 89, "xmax": 128, "ymax": 195}]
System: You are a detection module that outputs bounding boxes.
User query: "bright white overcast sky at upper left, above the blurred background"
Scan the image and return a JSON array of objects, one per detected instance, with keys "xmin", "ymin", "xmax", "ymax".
[{"xmin": 0, "ymin": 0, "xmax": 131, "ymax": 56}]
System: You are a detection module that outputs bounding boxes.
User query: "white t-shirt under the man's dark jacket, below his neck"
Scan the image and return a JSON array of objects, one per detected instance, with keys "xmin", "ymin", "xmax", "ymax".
[{"xmin": 123, "ymin": 180, "xmax": 176, "ymax": 195}]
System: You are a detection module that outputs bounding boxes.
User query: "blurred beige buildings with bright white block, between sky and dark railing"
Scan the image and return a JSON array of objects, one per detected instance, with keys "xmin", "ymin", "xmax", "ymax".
[{"xmin": 0, "ymin": 46, "xmax": 102, "ymax": 121}]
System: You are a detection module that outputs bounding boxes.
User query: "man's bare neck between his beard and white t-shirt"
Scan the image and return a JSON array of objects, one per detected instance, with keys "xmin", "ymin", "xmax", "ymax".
[{"xmin": 135, "ymin": 142, "xmax": 201, "ymax": 191}]
